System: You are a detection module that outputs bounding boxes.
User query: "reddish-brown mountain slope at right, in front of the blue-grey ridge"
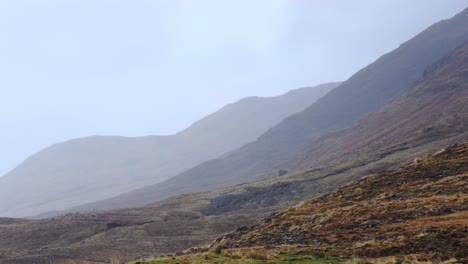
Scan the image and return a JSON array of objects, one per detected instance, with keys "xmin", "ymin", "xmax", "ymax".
[{"xmin": 279, "ymin": 39, "xmax": 468, "ymax": 174}]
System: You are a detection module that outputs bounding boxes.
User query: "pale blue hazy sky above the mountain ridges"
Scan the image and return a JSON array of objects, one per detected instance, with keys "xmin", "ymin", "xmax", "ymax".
[{"xmin": 0, "ymin": 0, "xmax": 468, "ymax": 175}]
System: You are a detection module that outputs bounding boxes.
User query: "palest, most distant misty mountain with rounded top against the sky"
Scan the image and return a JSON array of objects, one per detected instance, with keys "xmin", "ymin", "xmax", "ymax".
[{"xmin": 0, "ymin": 83, "xmax": 338, "ymax": 217}]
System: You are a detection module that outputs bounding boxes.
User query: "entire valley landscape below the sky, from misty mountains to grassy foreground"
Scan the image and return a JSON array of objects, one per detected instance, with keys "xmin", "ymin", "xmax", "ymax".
[{"xmin": 0, "ymin": 3, "xmax": 468, "ymax": 264}]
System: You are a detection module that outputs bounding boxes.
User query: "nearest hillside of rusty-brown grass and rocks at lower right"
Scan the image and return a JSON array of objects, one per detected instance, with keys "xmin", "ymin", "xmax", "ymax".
[{"xmin": 155, "ymin": 143, "xmax": 468, "ymax": 263}]
